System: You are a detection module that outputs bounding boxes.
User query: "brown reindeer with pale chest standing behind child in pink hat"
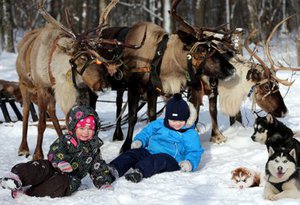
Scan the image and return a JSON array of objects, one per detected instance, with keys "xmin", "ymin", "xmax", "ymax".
[{"xmin": 16, "ymin": 0, "xmax": 122, "ymax": 159}]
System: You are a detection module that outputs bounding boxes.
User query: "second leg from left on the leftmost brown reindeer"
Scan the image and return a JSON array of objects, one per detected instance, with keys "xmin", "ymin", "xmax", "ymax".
[{"xmin": 33, "ymin": 89, "xmax": 49, "ymax": 160}]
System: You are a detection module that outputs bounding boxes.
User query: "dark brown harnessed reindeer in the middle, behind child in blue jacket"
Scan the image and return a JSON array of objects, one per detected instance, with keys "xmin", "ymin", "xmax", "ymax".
[{"xmin": 102, "ymin": 1, "xmax": 243, "ymax": 152}]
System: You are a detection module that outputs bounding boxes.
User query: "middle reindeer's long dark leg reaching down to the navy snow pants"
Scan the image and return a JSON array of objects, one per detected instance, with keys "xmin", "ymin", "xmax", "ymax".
[{"xmin": 120, "ymin": 85, "xmax": 140, "ymax": 153}]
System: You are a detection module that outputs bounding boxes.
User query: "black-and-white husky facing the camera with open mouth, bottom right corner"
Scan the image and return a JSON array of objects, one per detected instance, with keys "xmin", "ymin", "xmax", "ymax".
[{"xmin": 264, "ymin": 147, "xmax": 300, "ymax": 201}]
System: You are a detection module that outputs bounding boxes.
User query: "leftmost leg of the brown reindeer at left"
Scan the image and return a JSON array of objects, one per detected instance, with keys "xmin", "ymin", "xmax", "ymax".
[{"xmin": 18, "ymin": 83, "xmax": 31, "ymax": 157}]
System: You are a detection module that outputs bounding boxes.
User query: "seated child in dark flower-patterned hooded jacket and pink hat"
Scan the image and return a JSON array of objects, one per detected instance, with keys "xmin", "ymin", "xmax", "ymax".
[{"xmin": 0, "ymin": 106, "xmax": 114, "ymax": 197}]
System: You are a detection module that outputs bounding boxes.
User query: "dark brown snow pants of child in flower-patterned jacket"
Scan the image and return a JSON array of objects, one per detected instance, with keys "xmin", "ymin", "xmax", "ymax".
[{"xmin": 11, "ymin": 160, "xmax": 71, "ymax": 198}]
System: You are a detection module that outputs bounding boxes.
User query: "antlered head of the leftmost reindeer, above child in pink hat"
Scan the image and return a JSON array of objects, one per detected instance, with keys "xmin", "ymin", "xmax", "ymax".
[{"xmin": 38, "ymin": 0, "xmax": 146, "ymax": 90}]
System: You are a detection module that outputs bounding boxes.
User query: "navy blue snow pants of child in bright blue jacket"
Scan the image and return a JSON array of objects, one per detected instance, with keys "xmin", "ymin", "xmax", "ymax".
[{"xmin": 110, "ymin": 148, "xmax": 180, "ymax": 178}]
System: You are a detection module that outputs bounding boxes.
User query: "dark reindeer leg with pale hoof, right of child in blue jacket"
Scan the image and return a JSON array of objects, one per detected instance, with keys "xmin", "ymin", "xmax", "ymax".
[{"xmin": 209, "ymin": 96, "xmax": 226, "ymax": 144}]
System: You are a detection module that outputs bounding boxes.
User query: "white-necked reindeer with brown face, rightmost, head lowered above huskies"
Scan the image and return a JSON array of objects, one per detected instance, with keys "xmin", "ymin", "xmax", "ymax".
[{"xmin": 193, "ymin": 17, "xmax": 297, "ymax": 143}]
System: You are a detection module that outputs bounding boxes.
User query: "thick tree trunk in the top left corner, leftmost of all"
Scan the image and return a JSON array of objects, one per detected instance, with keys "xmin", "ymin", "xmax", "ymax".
[{"xmin": 3, "ymin": 0, "xmax": 15, "ymax": 52}]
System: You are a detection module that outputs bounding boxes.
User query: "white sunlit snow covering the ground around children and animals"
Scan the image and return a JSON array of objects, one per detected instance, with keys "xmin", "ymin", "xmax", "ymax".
[{"xmin": 0, "ymin": 34, "xmax": 300, "ymax": 205}]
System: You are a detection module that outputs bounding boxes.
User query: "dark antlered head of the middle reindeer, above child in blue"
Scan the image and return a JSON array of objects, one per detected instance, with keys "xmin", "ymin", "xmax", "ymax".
[{"xmin": 170, "ymin": 0, "xmax": 242, "ymax": 80}]
